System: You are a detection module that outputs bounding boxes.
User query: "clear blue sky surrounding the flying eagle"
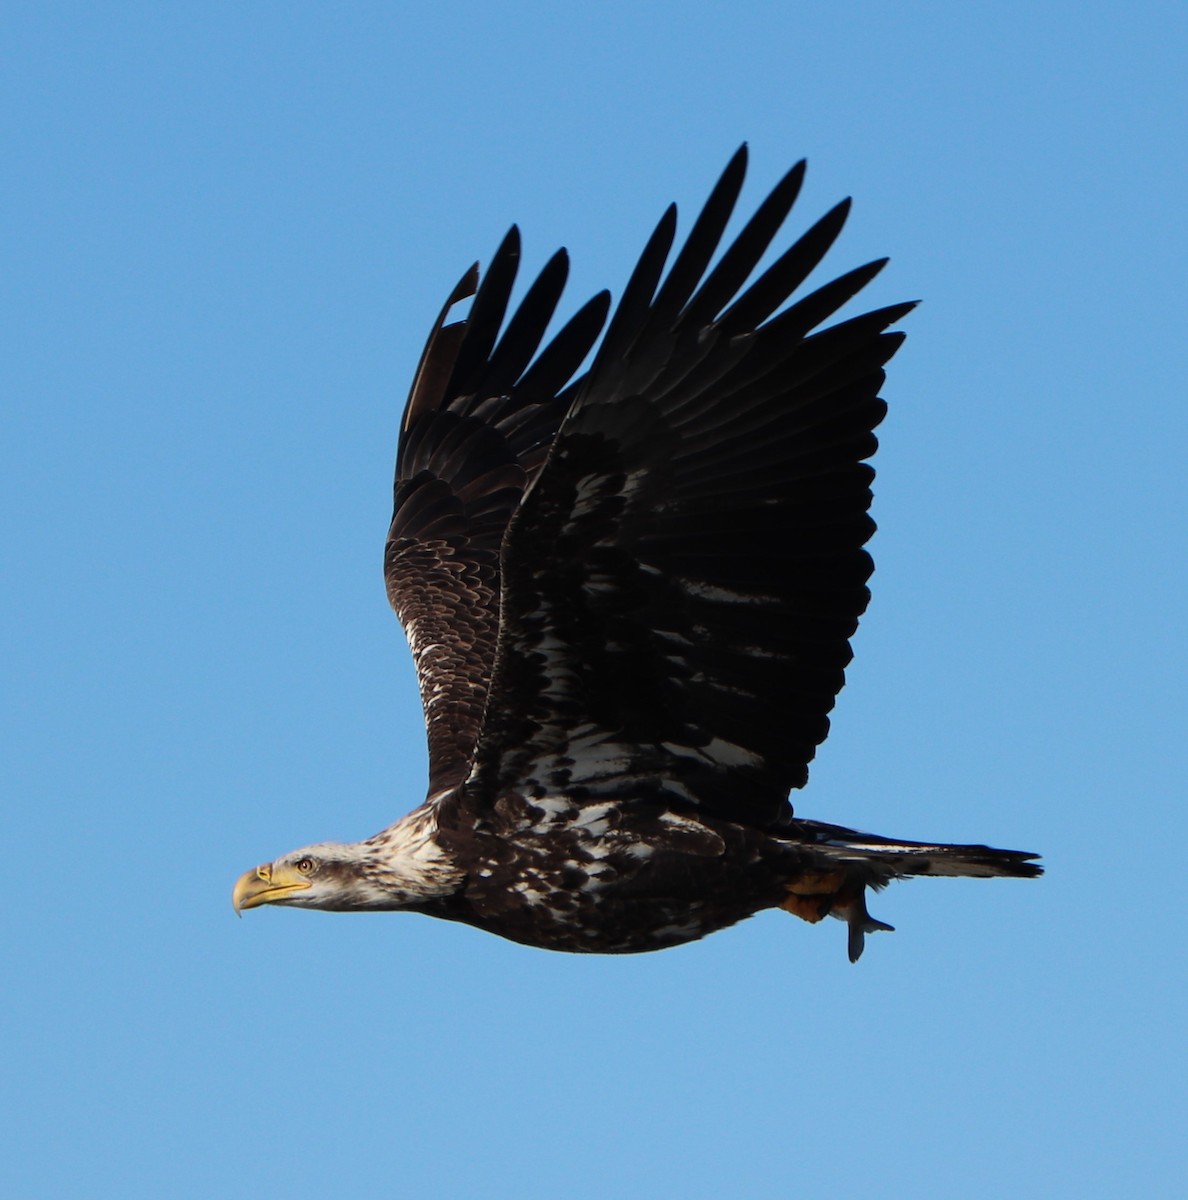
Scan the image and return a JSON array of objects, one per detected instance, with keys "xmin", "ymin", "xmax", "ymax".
[{"xmin": 0, "ymin": 0, "xmax": 1188, "ymax": 1200}]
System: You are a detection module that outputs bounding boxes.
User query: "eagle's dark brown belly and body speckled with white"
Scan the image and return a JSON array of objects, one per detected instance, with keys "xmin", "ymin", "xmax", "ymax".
[{"xmin": 426, "ymin": 797, "xmax": 799, "ymax": 954}]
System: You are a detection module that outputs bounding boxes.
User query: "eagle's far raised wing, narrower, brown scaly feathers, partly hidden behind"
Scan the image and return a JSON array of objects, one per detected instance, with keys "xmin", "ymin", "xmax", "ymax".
[{"xmin": 384, "ymin": 228, "xmax": 608, "ymax": 794}]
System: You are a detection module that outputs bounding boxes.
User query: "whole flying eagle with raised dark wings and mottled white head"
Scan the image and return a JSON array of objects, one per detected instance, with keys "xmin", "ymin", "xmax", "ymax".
[{"xmin": 233, "ymin": 145, "xmax": 1040, "ymax": 961}]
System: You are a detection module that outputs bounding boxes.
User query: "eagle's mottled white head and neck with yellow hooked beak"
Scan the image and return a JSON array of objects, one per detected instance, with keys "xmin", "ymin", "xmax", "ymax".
[{"xmin": 232, "ymin": 809, "xmax": 461, "ymax": 912}]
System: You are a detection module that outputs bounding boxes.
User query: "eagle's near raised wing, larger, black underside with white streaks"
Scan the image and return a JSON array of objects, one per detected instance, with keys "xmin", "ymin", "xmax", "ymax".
[{"xmin": 467, "ymin": 148, "xmax": 912, "ymax": 824}]
